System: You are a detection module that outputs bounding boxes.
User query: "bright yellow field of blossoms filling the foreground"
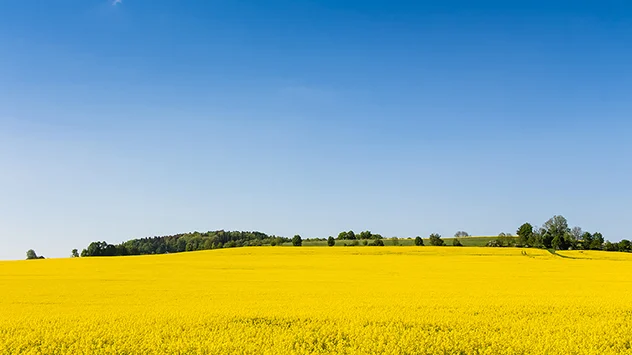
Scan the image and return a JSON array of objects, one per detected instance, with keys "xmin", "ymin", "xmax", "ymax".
[{"xmin": 0, "ymin": 247, "xmax": 632, "ymax": 354}]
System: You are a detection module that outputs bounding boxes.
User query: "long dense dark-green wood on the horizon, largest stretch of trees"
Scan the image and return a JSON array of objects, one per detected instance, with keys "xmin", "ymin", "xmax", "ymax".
[{"xmin": 79, "ymin": 230, "xmax": 290, "ymax": 256}]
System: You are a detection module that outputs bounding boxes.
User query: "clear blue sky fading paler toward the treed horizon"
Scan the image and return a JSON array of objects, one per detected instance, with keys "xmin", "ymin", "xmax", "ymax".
[{"xmin": 0, "ymin": 0, "xmax": 632, "ymax": 259}]
